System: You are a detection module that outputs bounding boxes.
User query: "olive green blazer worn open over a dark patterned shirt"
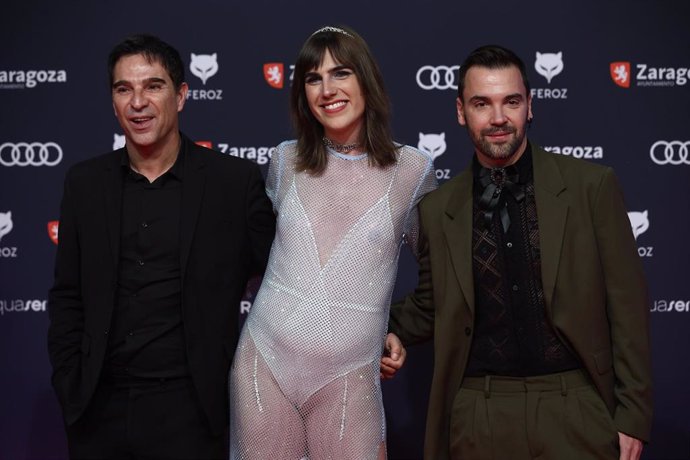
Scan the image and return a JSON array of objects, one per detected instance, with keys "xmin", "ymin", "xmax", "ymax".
[{"xmin": 390, "ymin": 144, "xmax": 652, "ymax": 460}]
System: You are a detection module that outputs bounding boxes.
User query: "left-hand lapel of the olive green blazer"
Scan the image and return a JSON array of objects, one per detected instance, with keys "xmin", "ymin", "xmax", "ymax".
[{"xmin": 443, "ymin": 166, "xmax": 474, "ymax": 312}]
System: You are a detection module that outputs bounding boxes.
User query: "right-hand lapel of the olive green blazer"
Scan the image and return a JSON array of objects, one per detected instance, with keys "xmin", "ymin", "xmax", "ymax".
[{"xmin": 532, "ymin": 145, "xmax": 569, "ymax": 311}]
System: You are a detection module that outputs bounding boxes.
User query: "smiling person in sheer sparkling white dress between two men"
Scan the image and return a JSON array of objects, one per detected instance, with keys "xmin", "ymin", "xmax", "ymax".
[{"xmin": 230, "ymin": 27, "xmax": 436, "ymax": 460}]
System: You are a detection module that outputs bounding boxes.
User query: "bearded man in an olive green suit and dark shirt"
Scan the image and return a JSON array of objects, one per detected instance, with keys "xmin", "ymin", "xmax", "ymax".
[{"xmin": 390, "ymin": 46, "xmax": 652, "ymax": 460}]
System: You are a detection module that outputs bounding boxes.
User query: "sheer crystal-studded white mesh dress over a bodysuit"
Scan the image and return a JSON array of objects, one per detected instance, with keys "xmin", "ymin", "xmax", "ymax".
[{"xmin": 230, "ymin": 141, "xmax": 436, "ymax": 460}]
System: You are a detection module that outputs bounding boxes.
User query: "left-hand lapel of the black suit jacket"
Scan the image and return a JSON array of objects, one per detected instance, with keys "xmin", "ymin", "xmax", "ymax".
[{"xmin": 101, "ymin": 150, "xmax": 122, "ymax": 270}]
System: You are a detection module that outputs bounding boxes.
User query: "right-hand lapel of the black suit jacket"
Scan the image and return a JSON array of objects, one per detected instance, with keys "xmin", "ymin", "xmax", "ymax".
[{"xmin": 180, "ymin": 137, "xmax": 206, "ymax": 280}]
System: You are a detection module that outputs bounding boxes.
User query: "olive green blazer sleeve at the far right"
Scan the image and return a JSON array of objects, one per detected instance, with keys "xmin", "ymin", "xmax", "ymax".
[{"xmin": 594, "ymin": 168, "xmax": 652, "ymax": 441}]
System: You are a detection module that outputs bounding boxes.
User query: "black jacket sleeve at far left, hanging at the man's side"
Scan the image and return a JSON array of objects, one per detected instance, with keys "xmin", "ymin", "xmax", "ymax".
[{"xmin": 48, "ymin": 173, "xmax": 84, "ymax": 406}]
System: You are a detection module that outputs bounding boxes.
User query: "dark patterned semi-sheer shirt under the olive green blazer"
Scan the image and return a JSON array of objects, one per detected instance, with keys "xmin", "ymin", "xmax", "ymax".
[{"xmin": 465, "ymin": 145, "xmax": 580, "ymax": 377}]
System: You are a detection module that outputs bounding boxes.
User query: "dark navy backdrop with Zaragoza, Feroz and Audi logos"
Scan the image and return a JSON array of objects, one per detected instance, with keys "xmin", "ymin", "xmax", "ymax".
[{"xmin": 0, "ymin": 0, "xmax": 690, "ymax": 460}]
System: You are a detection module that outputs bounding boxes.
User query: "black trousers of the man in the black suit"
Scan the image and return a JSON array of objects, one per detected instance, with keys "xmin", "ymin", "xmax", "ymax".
[{"xmin": 67, "ymin": 378, "xmax": 228, "ymax": 460}]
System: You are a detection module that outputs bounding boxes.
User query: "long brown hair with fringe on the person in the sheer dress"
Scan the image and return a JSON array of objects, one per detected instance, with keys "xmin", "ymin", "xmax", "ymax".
[{"xmin": 290, "ymin": 26, "xmax": 398, "ymax": 175}]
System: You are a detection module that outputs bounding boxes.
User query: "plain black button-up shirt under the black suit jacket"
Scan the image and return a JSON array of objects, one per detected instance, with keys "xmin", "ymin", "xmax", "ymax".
[{"xmin": 105, "ymin": 143, "xmax": 188, "ymax": 379}]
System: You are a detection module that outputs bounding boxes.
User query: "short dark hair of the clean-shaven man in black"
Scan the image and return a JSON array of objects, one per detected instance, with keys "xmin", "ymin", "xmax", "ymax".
[{"xmin": 108, "ymin": 34, "xmax": 184, "ymax": 89}]
